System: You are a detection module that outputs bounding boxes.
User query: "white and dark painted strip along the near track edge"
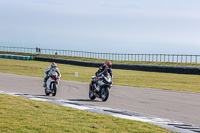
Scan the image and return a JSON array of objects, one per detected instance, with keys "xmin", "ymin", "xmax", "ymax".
[{"xmin": 0, "ymin": 91, "xmax": 200, "ymax": 133}]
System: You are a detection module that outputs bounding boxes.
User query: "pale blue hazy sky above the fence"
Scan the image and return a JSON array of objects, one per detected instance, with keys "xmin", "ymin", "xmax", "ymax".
[{"xmin": 0, "ymin": 0, "xmax": 200, "ymax": 55}]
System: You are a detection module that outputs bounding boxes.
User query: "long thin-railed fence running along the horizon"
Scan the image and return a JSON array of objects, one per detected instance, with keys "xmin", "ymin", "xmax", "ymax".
[{"xmin": 0, "ymin": 46, "xmax": 200, "ymax": 63}]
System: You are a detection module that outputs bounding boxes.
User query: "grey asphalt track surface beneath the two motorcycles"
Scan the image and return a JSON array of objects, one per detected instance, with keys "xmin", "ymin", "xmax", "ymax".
[{"xmin": 0, "ymin": 73, "xmax": 200, "ymax": 126}]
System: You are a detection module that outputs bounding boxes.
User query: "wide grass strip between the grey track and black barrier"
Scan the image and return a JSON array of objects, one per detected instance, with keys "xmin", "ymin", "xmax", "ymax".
[{"xmin": 0, "ymin": 58, "xmax": 200, "ymax": 92}]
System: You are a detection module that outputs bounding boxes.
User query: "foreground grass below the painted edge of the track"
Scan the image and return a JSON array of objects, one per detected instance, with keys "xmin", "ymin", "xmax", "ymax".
[{"xmin": 0, "ymin": 94, "xmax": 174, "ymax": 133}]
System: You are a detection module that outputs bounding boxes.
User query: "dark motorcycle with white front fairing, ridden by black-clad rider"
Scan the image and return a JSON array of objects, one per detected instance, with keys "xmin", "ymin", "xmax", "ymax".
[{"xmin": 89, "ymin": 72, "xmax": 113, "ymax": 102}]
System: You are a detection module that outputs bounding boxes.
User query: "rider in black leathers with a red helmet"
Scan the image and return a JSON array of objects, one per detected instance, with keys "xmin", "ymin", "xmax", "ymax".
[{"xmin": 90, "ymin": 61, "xmax": 113, "ymax": 90}]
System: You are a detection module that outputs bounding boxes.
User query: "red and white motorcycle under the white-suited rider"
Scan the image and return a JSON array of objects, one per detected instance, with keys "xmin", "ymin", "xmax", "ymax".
[{"xmin": 45, "ymin": 73, "xmax": 60, "ymax": 96}]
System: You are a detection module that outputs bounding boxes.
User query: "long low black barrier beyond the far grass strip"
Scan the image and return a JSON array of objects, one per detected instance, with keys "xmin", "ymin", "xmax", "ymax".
[{"xmin": 35, "ymin": 57, "xmax": 200, "ymax": 75}]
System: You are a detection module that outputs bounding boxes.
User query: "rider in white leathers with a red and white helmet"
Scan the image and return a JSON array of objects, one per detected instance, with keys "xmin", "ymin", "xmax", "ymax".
[{"xmin": 43, "ymin": 62, "xmax": 61, "ymax": 90}]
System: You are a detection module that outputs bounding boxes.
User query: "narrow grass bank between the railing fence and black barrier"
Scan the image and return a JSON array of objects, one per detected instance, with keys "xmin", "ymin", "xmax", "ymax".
[{"xmin": 0, "ymin": 51, "xmax": 200, "ymax": 67}]
